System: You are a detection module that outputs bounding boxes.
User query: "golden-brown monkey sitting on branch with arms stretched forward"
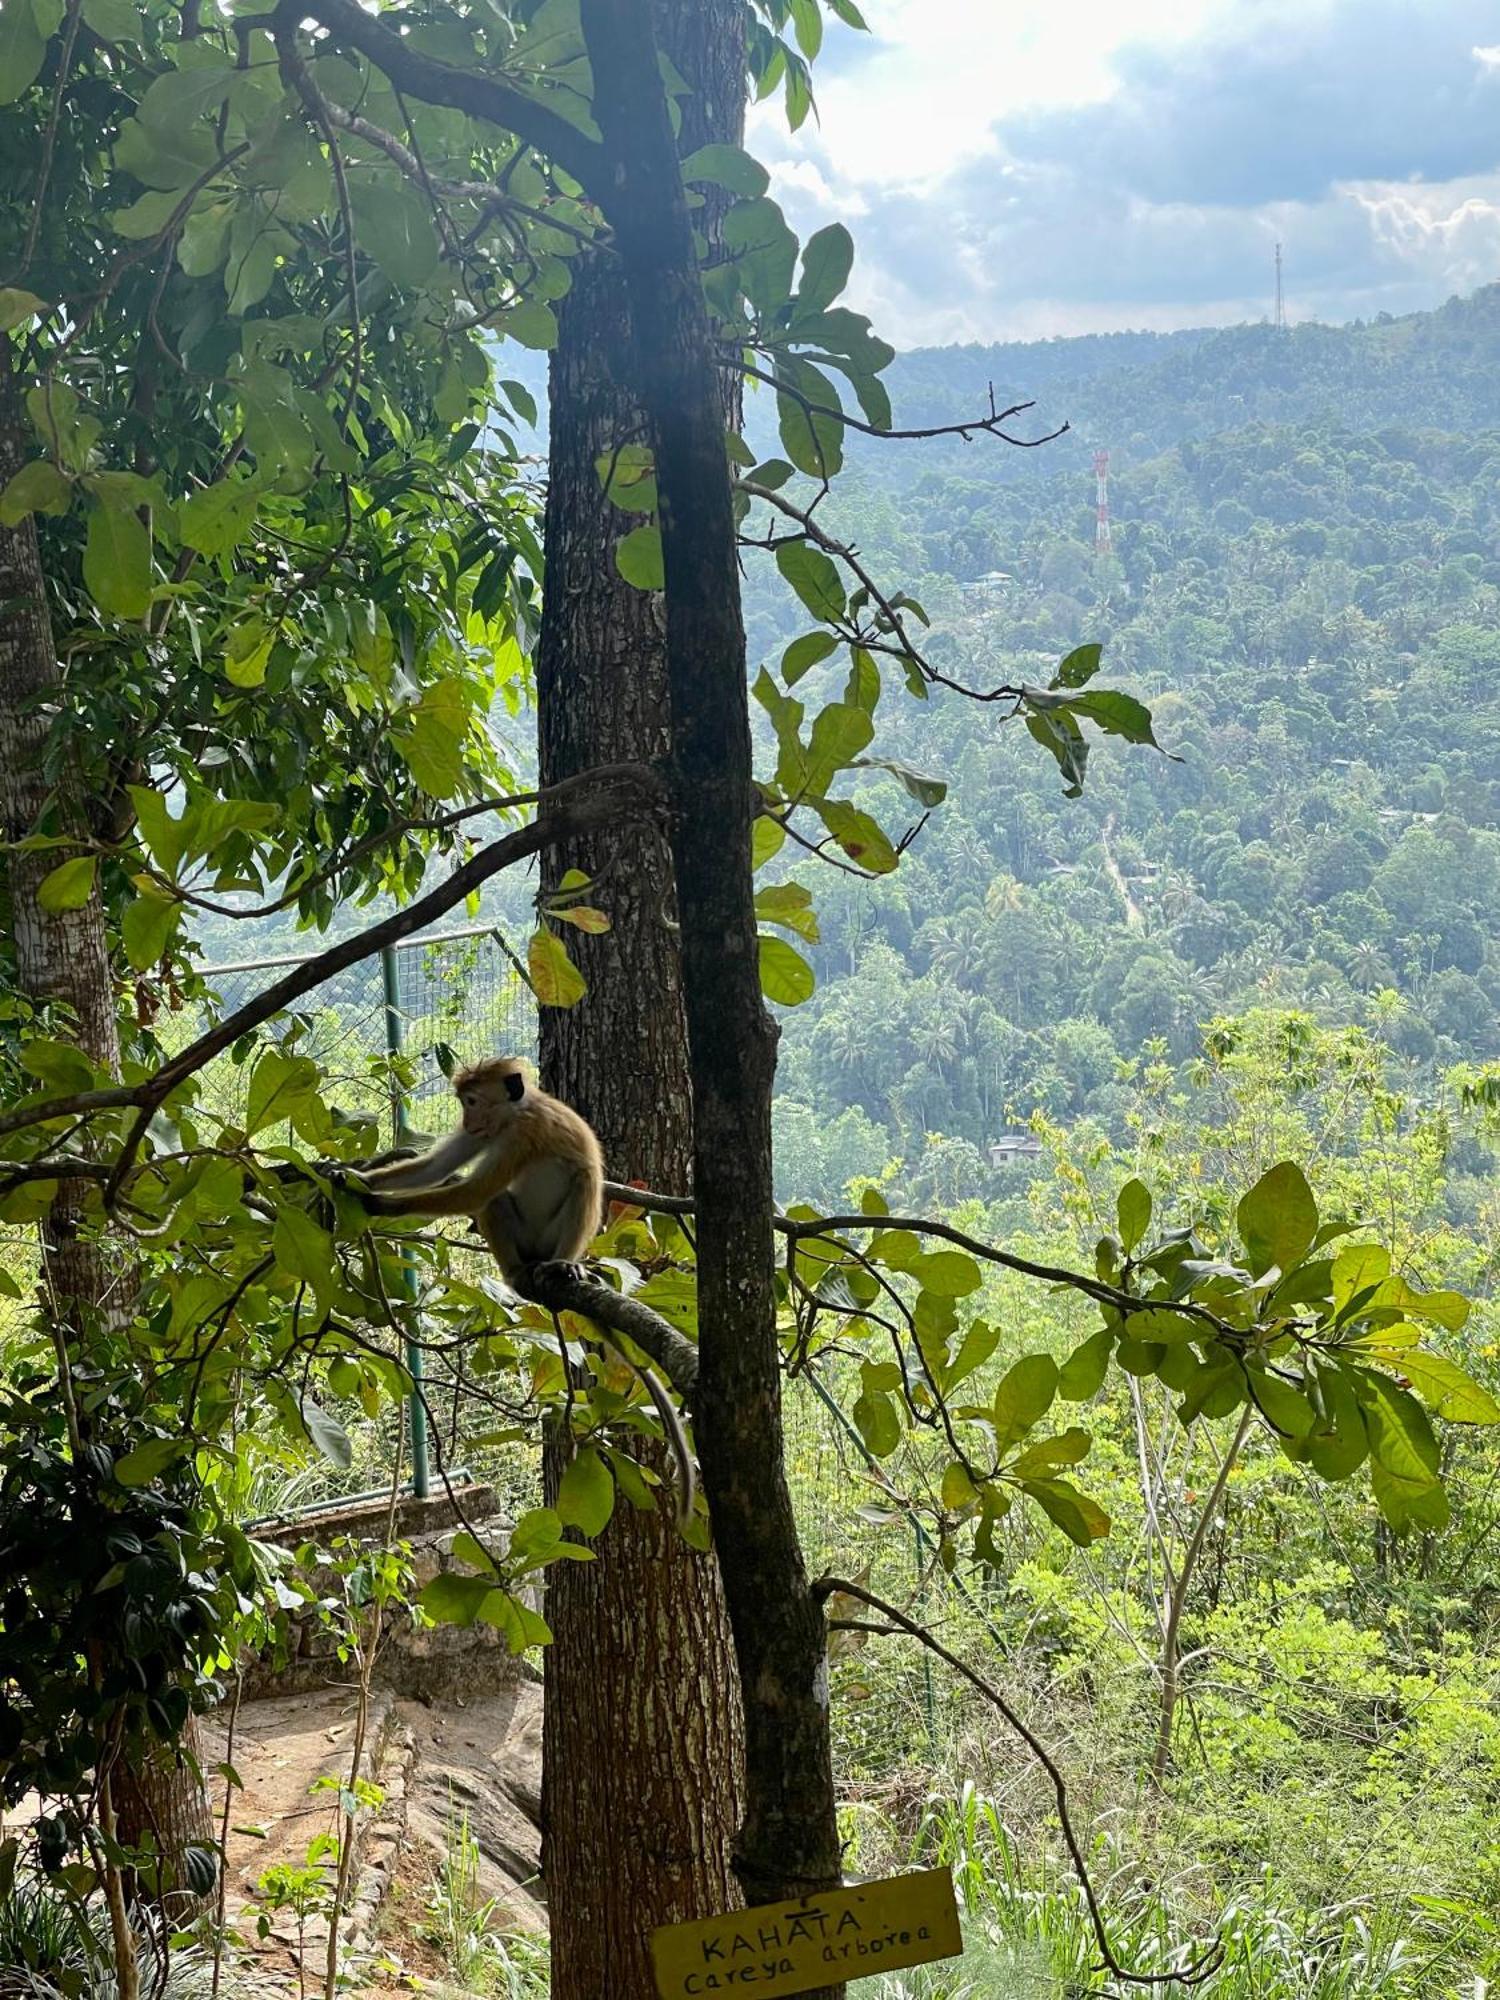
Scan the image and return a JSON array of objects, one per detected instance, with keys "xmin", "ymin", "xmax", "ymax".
[{"xmin": 352, "ymin": 1056, "xmax": 696, "ymax": 1522}]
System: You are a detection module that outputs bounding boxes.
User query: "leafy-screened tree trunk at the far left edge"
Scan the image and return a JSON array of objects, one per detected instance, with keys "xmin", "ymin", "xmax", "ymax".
[{"xmin": 0, "ymin": 360, "xmax": 214, "ymax": 1916}]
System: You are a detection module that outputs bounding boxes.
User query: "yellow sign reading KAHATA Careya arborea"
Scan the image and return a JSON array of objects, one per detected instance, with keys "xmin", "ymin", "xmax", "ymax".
[{"xmin": 652, "ymin": 1868, "xmax": 964, "ymax": 2000}]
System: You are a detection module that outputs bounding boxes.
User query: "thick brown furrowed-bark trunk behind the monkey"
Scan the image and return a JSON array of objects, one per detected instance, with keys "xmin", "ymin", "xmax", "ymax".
[{"xmin": 536, "ymin": 0, "xmax": 744, "ymax": 2000}]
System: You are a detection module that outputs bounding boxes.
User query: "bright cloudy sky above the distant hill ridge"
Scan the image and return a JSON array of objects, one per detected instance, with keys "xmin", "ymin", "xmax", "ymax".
[{"xmin": 750, "ymin": 0, "xmax": 1500, "ymax": 346}]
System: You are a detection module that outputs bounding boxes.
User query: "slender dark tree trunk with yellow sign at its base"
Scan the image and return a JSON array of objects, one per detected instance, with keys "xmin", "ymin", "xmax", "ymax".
[{"xmin": 582, "ymin": 0, "xmax": 840, "ymax": 1952}]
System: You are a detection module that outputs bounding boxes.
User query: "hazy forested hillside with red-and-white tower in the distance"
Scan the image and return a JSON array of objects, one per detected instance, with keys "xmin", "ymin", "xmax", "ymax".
[{"xmin": 764, "ymin": 288, "xmax": 1500, "ymax": 1198}]
